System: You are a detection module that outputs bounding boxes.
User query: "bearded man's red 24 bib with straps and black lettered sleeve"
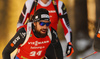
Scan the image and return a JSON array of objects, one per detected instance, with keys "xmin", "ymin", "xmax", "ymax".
[{"xmin": 2, "ymin": 23, "xmax": 55, "ymax": 59}]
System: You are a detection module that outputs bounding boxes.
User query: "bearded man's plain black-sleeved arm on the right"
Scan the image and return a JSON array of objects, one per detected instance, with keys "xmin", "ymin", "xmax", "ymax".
[{"xmin": 48, "ymin": 27, "xmax": 63, "ymax": 59}]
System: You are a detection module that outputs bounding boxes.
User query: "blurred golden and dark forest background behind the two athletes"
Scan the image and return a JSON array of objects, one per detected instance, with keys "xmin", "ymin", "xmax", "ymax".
[{"xmin": 0, "ymin": 0, "xmax": 100, "ymax": 59}]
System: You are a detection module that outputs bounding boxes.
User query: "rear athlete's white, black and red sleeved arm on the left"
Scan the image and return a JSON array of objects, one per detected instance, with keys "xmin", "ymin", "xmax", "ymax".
[{"xmin": 17, "ymin": 0, "xmax": 34, "ymax": 28}]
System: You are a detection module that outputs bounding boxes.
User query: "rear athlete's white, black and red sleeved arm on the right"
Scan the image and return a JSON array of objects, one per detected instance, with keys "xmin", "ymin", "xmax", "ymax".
[{"xmin": 58, "ymin": 1, "xmax": 72, "ymax": 42}]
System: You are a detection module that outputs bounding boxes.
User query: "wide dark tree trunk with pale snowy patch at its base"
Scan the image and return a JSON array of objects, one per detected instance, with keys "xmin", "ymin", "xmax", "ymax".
[{"xmin": 72, "ymin": 0, "xmax": 92, "ymax": 59}]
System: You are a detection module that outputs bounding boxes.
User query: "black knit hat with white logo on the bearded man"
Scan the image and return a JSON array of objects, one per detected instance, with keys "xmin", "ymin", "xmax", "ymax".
[{"xmin": 32, "ymin": 8, "xmax": 50, "ymax": 22}]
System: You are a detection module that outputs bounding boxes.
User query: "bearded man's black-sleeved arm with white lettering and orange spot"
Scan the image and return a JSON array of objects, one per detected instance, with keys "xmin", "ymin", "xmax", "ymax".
[{"xmin": 2, "ymin": 28, "xmax": 26, "ymax": 59}]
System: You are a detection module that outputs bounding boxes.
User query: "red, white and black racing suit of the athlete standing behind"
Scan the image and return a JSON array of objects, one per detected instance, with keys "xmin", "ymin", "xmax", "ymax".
[{"xmin": 17, "ymin": 0, "xmax": 72, "ymax": 42}]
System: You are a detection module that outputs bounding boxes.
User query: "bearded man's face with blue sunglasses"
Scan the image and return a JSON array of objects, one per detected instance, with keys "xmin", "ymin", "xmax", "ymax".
[{"xmin": 34, "ymin": 20, "xmax": 50, "ymax": 36}]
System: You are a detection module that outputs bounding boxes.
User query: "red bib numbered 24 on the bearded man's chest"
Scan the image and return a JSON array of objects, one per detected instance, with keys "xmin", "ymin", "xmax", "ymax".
[{"xmin": 17, "ymin": 25, "xmax": 51, "ymax": 59}]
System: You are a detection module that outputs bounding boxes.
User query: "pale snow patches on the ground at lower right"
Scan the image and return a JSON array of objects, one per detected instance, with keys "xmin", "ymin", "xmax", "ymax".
[{"xmin": 60, "ymin": 40, "xmax": 100, "ymax": 59}]
